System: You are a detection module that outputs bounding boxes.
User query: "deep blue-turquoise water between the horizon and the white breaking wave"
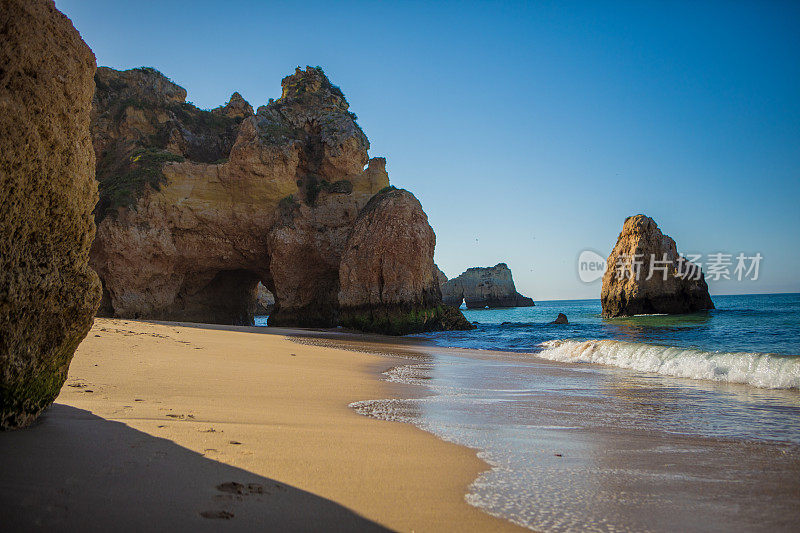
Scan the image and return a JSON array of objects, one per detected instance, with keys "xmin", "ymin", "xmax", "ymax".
[{"xmin": 418, "ymin": 294, "xmax": 800, "ymax": 355}]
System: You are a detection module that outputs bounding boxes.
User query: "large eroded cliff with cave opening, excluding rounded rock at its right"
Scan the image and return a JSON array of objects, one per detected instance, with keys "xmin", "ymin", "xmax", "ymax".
[{"xmin": 92, "ymin": 67, "xmax": 389, "ymax": 326}]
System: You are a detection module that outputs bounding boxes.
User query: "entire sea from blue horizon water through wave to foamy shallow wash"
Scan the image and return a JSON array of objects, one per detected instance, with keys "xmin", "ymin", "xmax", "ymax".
[{"xmin": 352, "ymin": 294, "xmax": 800, "ymax": 531}]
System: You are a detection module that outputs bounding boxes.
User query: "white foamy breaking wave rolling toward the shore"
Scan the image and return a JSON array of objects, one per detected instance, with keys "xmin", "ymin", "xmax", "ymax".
[{"xmin": 535, "ymin": 340, "xmax": 800, "ymax": 389}]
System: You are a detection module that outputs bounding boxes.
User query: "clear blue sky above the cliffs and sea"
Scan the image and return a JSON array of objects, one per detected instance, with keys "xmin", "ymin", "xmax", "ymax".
[{"xmin": 56, "ymin": 0, "xmax": 800, "ymax": 300}]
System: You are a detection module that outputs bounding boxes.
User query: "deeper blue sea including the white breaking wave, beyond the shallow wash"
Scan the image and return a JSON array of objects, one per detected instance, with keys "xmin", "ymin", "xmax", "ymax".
[{"xmin": 421, "ymin": 294, "xmax": 800, "ymax": 389}]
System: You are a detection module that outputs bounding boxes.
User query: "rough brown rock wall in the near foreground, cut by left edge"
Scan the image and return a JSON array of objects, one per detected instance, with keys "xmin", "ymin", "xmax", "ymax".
[{"xmin": 0, "ymin": 0, "xmax": 100, "ymax": 429}]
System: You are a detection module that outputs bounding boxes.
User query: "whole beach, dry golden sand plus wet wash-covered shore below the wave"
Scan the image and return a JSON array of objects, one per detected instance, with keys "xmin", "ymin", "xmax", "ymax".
[{"xmin": 0, "ymin": 304, "xmax": 800, "ymax": 532}]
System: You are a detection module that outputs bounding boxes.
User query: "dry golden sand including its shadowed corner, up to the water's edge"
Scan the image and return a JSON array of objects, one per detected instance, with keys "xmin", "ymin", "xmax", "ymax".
[{"xmin": 0, "ymin": 319, "xmax": 517, "ymax": 531}]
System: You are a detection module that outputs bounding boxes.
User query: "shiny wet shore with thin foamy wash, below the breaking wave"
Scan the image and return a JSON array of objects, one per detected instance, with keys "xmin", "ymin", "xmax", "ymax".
[{"xmin": 356, "ymin": 342, "xmax": 800, "ymax": 533}]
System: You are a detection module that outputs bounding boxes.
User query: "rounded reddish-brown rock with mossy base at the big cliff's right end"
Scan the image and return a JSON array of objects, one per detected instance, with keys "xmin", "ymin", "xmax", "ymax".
[{"xmin": 339, "ymin": 187, "xmax": 473, "ymax": 335}]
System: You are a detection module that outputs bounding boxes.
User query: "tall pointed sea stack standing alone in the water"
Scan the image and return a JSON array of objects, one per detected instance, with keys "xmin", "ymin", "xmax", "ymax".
[{"xmin": 600, "ymin": 215, "xmax": 714, "ymax": 318}]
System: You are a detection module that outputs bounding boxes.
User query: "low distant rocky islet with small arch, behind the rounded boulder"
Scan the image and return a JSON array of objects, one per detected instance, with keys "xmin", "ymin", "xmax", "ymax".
[{"xmin": 441, "ymin": 263, "xmax": 534, "ymax": 309}]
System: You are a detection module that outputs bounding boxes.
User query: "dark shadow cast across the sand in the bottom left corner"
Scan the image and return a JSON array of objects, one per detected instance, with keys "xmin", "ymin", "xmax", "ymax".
[{"xmin": 0, "ymin": 404, "xmax": 387, "ymax": 531}]
